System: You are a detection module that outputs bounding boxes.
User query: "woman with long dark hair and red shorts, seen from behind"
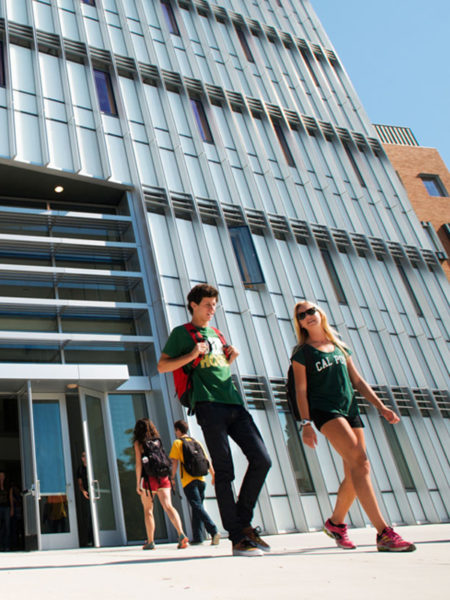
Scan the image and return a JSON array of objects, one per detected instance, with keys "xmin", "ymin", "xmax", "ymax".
[{"xmin": 133, "ymin": 419, "xmax": 188, "ymax": 550}]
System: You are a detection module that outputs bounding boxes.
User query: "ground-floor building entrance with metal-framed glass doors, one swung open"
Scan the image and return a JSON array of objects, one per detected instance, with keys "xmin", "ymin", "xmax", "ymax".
[{"xmin": 18, "ymin": 384, "xmax": 125, "ymax": 550}]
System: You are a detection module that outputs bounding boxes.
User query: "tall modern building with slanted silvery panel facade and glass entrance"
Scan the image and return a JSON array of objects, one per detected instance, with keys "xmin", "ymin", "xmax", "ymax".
[{"xmin": 0, "ymin": 0, "xmax": 450, "ymax": 549}]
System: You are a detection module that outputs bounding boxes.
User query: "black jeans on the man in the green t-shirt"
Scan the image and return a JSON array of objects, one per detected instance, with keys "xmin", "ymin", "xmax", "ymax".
[{"xmin": 195, "ymin": 402, "xmax": 272, "ymax": 544}]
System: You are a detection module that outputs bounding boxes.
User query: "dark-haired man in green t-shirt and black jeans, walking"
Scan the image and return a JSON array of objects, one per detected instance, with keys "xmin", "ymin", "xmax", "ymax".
[{"xmin": 158, "ymin": 284, "xmax": 272, "ymax": 556}]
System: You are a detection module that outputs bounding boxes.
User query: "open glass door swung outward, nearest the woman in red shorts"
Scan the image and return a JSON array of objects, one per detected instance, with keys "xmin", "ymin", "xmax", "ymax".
[{"xmin": 80, "ymin": 388, "xmax": 126, "ymax": 547}]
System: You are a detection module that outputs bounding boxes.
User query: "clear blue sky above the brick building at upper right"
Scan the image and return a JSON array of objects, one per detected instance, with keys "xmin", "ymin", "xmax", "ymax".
[{"xmin": 310, "ymin": 0, "xmax": 450, "ymax": 168}]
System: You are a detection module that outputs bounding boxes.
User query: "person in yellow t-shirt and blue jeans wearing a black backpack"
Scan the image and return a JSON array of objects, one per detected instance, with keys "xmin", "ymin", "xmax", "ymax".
[{"xmin": 169, "ymin": 419, "xmax": 220, "ymax": 546}]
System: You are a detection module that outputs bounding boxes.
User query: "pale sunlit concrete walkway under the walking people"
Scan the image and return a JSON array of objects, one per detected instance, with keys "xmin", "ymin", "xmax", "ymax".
[{"xmin": 0, "ymin": 525, "xmax": 450, "ymax": 600}]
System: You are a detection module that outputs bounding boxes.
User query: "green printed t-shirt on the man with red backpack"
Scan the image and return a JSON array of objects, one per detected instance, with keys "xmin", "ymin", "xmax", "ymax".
[{"xmin": 163, "ymin": 325, "xmax": 243, "ymax": 407}]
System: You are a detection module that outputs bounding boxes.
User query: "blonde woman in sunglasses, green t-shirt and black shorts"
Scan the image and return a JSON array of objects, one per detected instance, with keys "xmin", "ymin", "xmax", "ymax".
[{"xmin": 292, "ymin": 300, "xmax": 415, "ymax": 552}]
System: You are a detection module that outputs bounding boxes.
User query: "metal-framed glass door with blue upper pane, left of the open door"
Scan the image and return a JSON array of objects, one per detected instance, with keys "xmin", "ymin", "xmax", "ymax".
[{"xmin": 32, "ymin": 394, "xmax": 78, "ymax": 550}]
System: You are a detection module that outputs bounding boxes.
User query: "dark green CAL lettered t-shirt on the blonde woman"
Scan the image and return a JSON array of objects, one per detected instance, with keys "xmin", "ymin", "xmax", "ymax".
[{"xmin": 292, "ymin": 344, "xmax": 359, "ymax": 417}]
